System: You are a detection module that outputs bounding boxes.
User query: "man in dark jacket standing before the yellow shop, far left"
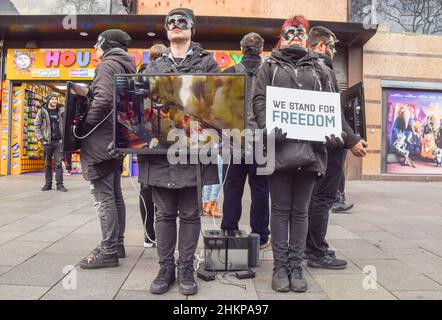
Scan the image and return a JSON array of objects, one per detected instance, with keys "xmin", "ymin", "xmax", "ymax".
[{"xmin": 35, "ymin": 93, "xmax": 67, "ymax": 192}]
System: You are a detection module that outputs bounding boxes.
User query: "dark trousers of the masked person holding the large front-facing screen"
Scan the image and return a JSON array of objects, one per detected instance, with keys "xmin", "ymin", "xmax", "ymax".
[{"xmin": 152, "ymin": 187, "xmax": 201, "ymax": 266}]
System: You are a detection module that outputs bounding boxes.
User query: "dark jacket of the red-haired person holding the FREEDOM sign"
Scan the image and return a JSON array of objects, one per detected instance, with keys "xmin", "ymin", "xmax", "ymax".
[{"xmin": 253, "ymin": 49, "xmax": 332, "ymax": 174}]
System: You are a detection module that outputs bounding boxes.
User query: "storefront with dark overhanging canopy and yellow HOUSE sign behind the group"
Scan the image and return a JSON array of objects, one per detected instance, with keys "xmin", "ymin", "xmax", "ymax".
[{"xmin": 0, "ymin": 15, "xmax": 376, "ymax": 178}]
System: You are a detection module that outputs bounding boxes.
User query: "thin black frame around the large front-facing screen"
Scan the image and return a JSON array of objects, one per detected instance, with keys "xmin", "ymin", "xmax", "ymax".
[{"xmin": 112, "ymin": 72, "xmax": 251, "ymax": 155}]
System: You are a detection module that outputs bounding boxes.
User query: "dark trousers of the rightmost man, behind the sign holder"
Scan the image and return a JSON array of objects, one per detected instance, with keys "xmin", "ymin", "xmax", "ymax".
[{"xmin": 306, "ymin": 148, "xmax": 345, "ymax": 258}]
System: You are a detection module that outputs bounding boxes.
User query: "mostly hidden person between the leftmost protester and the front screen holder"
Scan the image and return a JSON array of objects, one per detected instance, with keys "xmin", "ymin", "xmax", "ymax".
[{"xmin": 137, "ymin": 43, "xmax": 167, "ymax": 248}]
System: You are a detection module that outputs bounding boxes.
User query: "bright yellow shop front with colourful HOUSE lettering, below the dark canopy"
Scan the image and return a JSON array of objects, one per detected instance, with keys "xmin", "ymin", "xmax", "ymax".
[{"xmin": 1, "ymin": 49, "xmax": 268, "ymax": 175}]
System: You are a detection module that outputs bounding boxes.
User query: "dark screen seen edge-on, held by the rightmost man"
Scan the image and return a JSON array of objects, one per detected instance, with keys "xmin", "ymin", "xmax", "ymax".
[{"xmin": 341, "ymin": 81, "xmax": 367, "ymax": 140}]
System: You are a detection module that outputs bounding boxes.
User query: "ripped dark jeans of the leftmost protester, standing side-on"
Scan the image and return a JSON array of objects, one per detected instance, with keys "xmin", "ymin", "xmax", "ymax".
[{"xmin": 91, "ymin": 170, "xmax": 126, "ymax": 254}]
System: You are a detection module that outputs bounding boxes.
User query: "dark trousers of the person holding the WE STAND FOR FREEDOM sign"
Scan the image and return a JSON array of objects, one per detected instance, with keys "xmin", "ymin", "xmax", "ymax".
[{"xmin": 269, "ymin": 170, "xmax": 318, "ymax": 268}]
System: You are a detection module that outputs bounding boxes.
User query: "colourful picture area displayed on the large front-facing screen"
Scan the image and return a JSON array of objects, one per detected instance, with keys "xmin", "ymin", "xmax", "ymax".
[{"xmin": 114, "ymin": 74, "xmax": 246, "ymax": 154}]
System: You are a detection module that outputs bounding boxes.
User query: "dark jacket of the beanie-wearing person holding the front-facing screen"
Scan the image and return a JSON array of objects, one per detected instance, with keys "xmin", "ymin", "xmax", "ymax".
[{"xmin": 138, "ymin": 42, "xmax": 220, "ymax": 189}]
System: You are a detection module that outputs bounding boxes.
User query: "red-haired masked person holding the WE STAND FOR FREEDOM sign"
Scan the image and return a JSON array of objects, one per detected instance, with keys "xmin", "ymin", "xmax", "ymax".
[{"xmin": 253, "ymin": 16, "xmax": 331, "ymax": 292}]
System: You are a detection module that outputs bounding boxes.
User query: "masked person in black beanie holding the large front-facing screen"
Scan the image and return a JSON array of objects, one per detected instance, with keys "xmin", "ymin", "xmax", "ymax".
[{"xmin": 139, "ymin": 8, "xmax": 220, "ymax": 295}]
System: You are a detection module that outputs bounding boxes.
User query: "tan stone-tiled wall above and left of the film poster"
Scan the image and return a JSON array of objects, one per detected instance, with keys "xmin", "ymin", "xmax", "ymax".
[{"xmin": 362, "ymin": 30, "xmax": 442, "ymax": 176}]
